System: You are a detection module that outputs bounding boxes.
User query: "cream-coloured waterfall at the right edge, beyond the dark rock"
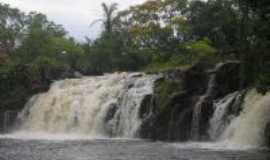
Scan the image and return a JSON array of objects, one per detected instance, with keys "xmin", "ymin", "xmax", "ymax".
[{"xmin": 222, "ymin": 90, "xmax": 270, "ymax": 146}]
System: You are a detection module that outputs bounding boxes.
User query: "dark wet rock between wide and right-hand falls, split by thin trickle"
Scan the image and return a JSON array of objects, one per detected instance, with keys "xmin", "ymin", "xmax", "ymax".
[{"xmin": 139, "ymin": 62, "xmax": 240, "ymax": 141}]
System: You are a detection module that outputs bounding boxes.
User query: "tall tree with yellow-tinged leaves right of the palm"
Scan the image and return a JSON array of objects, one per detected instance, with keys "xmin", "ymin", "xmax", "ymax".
[{"xmin": 117, "ymin": 0, "xmax": 188, "ymax": 59}]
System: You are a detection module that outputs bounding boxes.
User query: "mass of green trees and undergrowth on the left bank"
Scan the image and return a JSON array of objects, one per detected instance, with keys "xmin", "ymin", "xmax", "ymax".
[{"xmin": 0, "ymin": 4, "xmax": 84, "ymax": 109}]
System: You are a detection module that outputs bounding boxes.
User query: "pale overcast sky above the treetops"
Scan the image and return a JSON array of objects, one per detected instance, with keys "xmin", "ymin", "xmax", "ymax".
[{"xmin": 0, "ymin": 0, "xmax": 148, "ymax": 41}]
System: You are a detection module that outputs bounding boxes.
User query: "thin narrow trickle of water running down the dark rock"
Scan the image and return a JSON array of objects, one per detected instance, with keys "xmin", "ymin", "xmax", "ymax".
[{"xmin": 191, "ymin": 63, "xmax": 224, "ymax": 140}]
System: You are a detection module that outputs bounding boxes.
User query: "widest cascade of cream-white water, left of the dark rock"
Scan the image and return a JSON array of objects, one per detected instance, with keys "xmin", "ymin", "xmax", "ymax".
[{"xmin": 15, "ymin": 73, "xmax": 157, "ymax": 137}]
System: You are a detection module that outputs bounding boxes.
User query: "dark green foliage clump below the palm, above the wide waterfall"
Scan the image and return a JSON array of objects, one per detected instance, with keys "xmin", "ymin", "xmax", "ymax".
[{"xmin": 81, "ymin": 33, "xmax": 150, "ymax": 74}]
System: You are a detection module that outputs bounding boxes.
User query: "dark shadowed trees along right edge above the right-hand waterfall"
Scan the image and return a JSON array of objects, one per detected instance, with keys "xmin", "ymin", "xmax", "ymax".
[{"xmin": 237, "ymin": 0, "xmax": 270, "ymax": 90}]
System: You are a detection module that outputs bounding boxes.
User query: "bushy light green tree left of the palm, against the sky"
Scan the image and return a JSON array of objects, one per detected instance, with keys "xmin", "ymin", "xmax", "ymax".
[{"xmin": 16, "ymin": 12, "xmax": 66, "ymax": 63}]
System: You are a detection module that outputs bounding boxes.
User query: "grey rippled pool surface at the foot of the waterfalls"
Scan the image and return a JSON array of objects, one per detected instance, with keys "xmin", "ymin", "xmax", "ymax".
[{"xmin": 0, "ymin": 138, "xmax": 270, "ymax": 160}]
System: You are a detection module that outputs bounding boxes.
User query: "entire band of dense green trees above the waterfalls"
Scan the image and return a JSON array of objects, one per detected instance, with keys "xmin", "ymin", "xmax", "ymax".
[{"xmin": 0, "ymin": 0, "xmax": 270, "ymax": 109}]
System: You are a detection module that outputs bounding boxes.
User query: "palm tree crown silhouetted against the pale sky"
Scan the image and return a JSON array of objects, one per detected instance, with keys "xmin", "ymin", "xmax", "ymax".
[{"xmin": 91, "ymin": 2, "xmax": 118, "ymax": 34}]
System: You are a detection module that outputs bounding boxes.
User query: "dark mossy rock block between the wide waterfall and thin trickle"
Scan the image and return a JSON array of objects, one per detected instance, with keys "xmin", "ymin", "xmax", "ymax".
[{"xmin": 140, "ymin": 63, "xmax": 210, "ymax": 141}]
